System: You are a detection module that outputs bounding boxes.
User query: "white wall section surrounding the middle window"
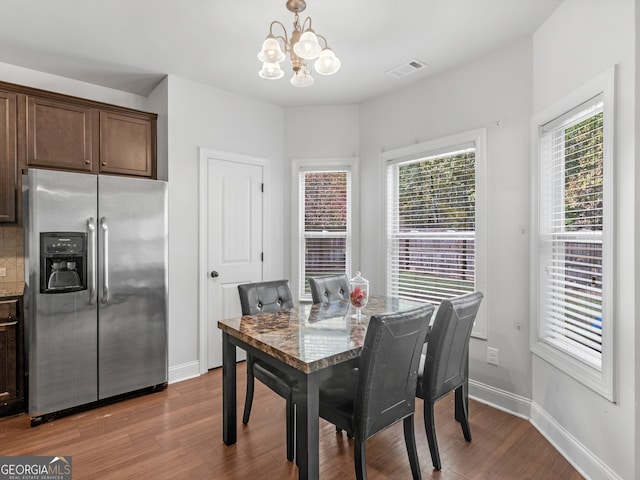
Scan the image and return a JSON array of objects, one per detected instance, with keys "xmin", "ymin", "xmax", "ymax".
[{"xmin": 360, "ymin": 39, "xmax": 532, "ymax": 410}]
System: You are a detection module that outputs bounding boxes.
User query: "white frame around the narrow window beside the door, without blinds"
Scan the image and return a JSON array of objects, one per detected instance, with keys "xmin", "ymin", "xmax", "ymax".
[{"xmin": 290, "ymin": 157, "xmax": 360, "ymax": 302}]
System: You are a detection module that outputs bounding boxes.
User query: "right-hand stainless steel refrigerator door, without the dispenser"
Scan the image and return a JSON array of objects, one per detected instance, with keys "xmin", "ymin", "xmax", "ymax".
[{"xmin": 98, "ymin": 176, "xmax": 167, "ymax": 399}]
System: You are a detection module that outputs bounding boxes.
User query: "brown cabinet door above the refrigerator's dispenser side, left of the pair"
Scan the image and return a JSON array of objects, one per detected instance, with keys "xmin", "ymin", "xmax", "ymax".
[{"xmin": 27, "ymin": 97, "xmax": 94, "ymax": 172}]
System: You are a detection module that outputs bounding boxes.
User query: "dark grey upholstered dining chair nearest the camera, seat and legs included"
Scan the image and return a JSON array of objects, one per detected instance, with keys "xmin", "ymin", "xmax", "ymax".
[{"xmin": 319, "ymin": 304, "xmax": 434, "ymax": 479}]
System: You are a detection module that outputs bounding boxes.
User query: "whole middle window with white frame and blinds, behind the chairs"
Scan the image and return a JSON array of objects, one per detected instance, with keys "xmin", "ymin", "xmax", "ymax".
[{"xmin": 387, "ymin": 131, "xmax": 486, "ymax": 337}]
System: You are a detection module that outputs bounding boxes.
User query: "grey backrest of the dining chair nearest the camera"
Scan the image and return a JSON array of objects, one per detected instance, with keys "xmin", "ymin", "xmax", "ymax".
[{"xmin": 354, "ymin": 304, "xmax": 435, "ymax": 440}]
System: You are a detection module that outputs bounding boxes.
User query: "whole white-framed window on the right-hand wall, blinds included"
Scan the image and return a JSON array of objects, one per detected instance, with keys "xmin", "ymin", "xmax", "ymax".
[{"xmin": 532, "ymin": 67, "xmax": 613, "ymax": 399}]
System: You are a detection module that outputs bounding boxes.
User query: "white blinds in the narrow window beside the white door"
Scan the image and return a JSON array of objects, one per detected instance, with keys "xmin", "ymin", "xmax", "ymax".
[{"xmin": 299, "ymin": 170, "xmax": 351, "ymax": 296}]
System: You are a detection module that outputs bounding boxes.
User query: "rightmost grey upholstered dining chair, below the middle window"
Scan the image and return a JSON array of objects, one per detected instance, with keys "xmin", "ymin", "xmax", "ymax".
[{"xmin": 416, "ymin": 292, "xmax": 483, "ymax": 470}]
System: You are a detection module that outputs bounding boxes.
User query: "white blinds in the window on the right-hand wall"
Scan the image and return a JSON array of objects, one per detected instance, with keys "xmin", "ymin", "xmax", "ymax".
[{"xmin": 540, "ymin": 96, "xmax": 607, "ymax": 370}]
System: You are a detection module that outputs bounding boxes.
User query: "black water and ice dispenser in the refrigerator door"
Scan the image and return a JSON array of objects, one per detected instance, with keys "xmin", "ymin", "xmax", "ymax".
[{"xmin": 40, "ymin": 232, "xmax": 87, "ymax": 293}]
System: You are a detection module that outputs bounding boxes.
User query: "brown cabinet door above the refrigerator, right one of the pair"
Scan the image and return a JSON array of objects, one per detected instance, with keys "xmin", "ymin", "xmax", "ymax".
[{"xmin": 100, "ymin": 111, "xmax": 155, "ymax": 177}]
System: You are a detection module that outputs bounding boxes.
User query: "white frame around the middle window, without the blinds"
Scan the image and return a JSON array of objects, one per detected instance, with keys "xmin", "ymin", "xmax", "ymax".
[{"xmin": 381, "ymin": 128, "xmax": 490, "ymax": 339}]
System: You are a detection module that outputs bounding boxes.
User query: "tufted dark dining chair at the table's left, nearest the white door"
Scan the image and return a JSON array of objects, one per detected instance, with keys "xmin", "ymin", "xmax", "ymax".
[{"xmin": 238, "ymin": 280, "xmax": 297, "ymax": 461}]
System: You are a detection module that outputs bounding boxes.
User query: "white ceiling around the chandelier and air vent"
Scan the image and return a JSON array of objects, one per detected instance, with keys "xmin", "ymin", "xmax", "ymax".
[{"xmin": 0, "ymin": 0, "xmax": 562, "ymax": 106}]
